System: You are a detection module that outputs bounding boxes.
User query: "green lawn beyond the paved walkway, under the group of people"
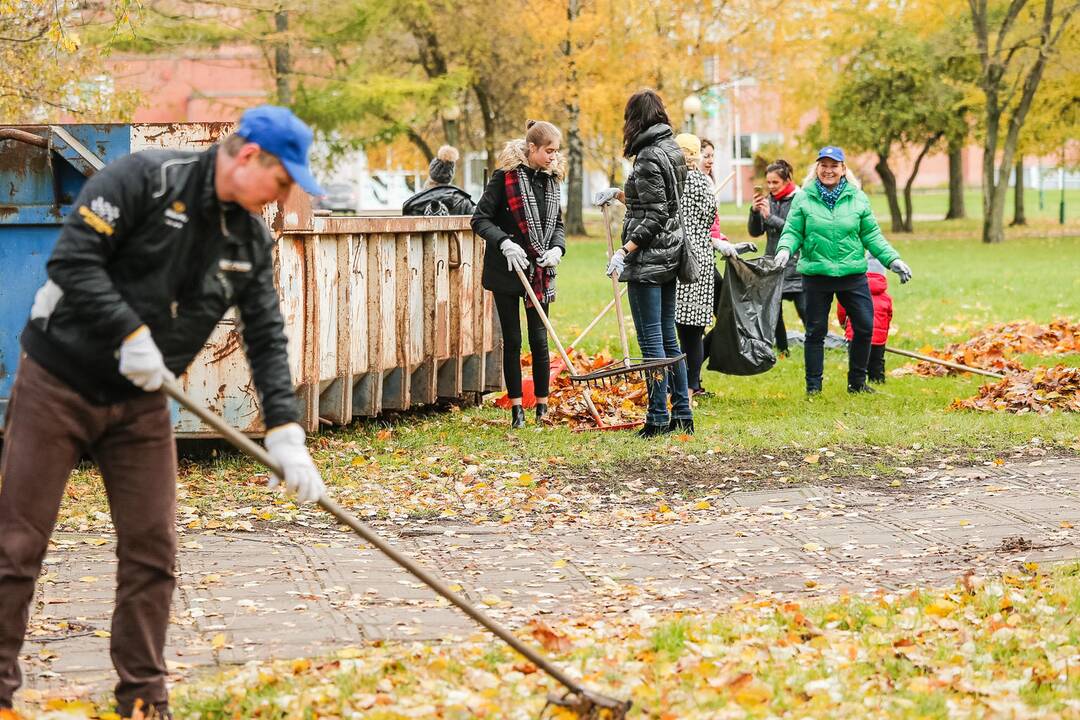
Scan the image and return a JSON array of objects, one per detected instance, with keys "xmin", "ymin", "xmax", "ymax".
[{"xmin": 48, "ymin": 220, "xmax": 1080, "ymax": 529}]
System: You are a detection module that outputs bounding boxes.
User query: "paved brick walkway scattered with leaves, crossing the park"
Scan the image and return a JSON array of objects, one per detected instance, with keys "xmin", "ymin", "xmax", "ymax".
[{"xmin": 16, "ymin": 459, "xmax": 1080, "ymax": 693}]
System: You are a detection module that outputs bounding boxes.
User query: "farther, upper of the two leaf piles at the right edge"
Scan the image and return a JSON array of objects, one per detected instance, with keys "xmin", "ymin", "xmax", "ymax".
[{"xmin": 897, "ymin": 318, "xmax": 1080, "ymax": 378}]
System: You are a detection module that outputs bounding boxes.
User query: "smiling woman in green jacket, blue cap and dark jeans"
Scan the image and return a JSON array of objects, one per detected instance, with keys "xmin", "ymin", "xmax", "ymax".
[{"xmin": 774, "ymin": 146, "xmax": 912, "ymax": 396}]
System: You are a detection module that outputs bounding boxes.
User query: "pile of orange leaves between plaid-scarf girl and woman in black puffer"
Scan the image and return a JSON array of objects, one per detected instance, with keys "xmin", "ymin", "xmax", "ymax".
[{"xmin": 523, "ymin": 350, "xmax": 649, "ymax": 429}]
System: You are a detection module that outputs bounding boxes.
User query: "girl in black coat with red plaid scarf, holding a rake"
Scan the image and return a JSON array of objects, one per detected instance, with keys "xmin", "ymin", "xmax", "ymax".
[{"xmin": 472, "ymin": 120, "xmax": 566, "ymax": 427}]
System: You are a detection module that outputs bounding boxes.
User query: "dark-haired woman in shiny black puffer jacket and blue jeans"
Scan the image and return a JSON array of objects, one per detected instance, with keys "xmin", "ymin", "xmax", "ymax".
[{"xmin": 607, "ymin": 90, "xmax": 693, "ymax": 437}]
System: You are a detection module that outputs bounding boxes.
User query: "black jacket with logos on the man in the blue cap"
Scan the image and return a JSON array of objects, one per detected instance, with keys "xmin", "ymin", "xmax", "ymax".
[{"xmin": 22, "ymin": 146, "xmax": 298, "ymax": 427}]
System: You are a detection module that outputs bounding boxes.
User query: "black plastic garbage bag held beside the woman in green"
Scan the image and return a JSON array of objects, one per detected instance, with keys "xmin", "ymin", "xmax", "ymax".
[{"xmin": 705, "ymin": 257, "xmax": 784, "ymax": 375}]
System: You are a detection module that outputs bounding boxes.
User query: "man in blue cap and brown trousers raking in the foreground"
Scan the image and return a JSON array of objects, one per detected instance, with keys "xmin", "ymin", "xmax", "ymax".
[{"xmin": 0, "ymin": 106, "xmax": 324, "ymax": 718}]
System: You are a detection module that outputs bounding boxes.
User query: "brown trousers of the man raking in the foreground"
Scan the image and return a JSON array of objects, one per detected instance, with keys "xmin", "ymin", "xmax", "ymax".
[{"xmin": 0, "ymin": 355, "xmax": 176, "ymax": 717}]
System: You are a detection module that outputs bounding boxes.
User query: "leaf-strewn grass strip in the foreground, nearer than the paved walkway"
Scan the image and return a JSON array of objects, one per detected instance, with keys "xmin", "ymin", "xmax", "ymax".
[{"xmin": 16, "ymin": 562, "xmax": 1080, "ymax": 720}]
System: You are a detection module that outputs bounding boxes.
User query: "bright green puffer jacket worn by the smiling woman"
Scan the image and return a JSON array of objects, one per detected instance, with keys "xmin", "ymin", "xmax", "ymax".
[{"xmin": 777, "ymin": 180, "xmax": 900, "ymax": 277}]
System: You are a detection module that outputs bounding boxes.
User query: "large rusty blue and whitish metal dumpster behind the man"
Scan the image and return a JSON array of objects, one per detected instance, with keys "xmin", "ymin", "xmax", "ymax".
[{"xmin": 0, "ymin": 123, "xmax": 502, "ymax": 437}]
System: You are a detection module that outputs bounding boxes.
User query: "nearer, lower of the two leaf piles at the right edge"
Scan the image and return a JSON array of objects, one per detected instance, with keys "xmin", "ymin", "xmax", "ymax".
[{"xmin": 950, "ymin": 365, "xmax": 1080, "ymax": 415}]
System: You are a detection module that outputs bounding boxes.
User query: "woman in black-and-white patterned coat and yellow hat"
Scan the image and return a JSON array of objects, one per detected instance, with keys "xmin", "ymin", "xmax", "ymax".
[{"xmin": 675, "ymin": 133, "xmax": 751, "ymax": 395}]
